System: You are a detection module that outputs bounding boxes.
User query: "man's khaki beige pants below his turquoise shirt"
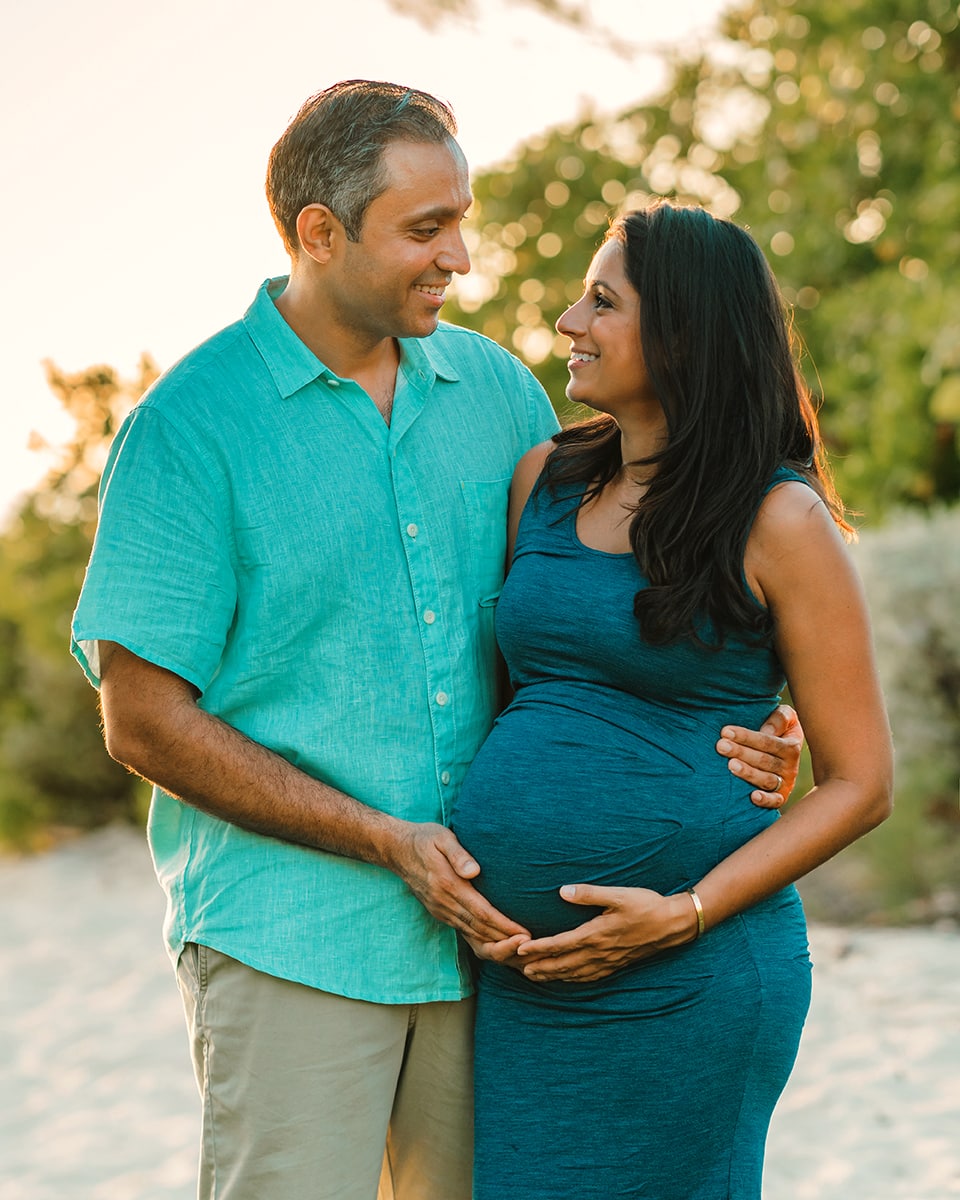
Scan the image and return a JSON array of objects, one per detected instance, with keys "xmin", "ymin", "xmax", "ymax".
[{"xmin": 178, "ymin": 944, "xmax": 474, "ymax": 1200}]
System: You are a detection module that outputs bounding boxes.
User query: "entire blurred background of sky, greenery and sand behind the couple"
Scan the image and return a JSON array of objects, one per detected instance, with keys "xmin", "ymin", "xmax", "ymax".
[{"xmin": 0, "ymin": 0, "xmax": 960, "ymax": 1200}]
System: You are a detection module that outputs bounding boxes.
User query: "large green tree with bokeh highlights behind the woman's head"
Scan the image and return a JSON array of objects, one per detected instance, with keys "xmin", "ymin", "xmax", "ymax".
[{"xmin": 450, "ymin": 0, "xmax": 960, "ymax": 521}]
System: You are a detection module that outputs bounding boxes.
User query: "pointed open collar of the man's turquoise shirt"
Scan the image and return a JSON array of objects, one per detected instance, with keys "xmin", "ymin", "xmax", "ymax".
[{"xmin": 244, "ymin": 275, "xmax": 460, "ymax": 400}]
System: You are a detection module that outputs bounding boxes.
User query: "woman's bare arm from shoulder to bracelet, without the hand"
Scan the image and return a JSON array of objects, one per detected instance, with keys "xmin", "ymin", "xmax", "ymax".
[{"xmin": 697, "ymin": 484, "xmax": 893, "ymax": 912}]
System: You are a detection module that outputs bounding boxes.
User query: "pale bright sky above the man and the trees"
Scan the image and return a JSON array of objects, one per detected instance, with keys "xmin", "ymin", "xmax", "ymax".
[{"xmin": 0, "ymin": 0, "xmax": 730, "ymax": 511}]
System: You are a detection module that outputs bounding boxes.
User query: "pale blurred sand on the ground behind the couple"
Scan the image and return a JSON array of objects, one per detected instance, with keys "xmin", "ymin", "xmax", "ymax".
[{"xmin": 0, "ymin": 829, "xmax": 960, "ymax": 1200}]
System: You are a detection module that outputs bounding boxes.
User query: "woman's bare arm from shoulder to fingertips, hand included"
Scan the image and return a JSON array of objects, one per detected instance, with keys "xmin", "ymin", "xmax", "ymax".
[{"xmin": 508, "ymin": 484, "xmax": 893, "ymax": 980}]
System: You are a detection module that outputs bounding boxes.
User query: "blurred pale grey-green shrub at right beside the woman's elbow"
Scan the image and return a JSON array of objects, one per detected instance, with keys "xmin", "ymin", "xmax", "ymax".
[{"xmin": 802, "ymin": 508, "xmax": 960, "ymax": 922}]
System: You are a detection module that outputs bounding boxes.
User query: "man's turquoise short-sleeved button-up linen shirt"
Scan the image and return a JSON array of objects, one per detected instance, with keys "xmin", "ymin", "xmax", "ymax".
[{"xmin": 73, "ymin": 280, "xmax": 557, "ymax": 1003}]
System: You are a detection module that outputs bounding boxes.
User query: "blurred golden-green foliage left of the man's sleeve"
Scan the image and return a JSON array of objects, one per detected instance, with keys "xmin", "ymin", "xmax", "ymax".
[{"xmin": 0, "ymin": 359, "xmax": 156, "ymax": 845}]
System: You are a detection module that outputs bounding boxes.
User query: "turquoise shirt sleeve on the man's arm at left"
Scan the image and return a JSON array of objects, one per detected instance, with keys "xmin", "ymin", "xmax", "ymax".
[{"xmin": 71, "ymin": 403, "xmax": 236, "ymax": 691}]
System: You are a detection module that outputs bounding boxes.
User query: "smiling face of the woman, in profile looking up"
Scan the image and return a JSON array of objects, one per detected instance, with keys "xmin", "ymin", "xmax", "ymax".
[{"xmin": 557, "ymin": 240, "xmax": 660, "ymax": 421}]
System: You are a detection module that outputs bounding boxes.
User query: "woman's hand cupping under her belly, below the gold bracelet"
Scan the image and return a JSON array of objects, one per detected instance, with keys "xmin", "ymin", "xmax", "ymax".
[{"xmin": 513, "ymin": 883, "xmax": 697, "ymax": 983}]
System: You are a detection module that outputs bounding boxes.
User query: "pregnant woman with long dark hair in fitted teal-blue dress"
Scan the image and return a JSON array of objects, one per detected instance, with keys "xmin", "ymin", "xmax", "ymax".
[{"xmin": 454, "ymin": 204, "xmax": 892, "ymax": 1200}]
